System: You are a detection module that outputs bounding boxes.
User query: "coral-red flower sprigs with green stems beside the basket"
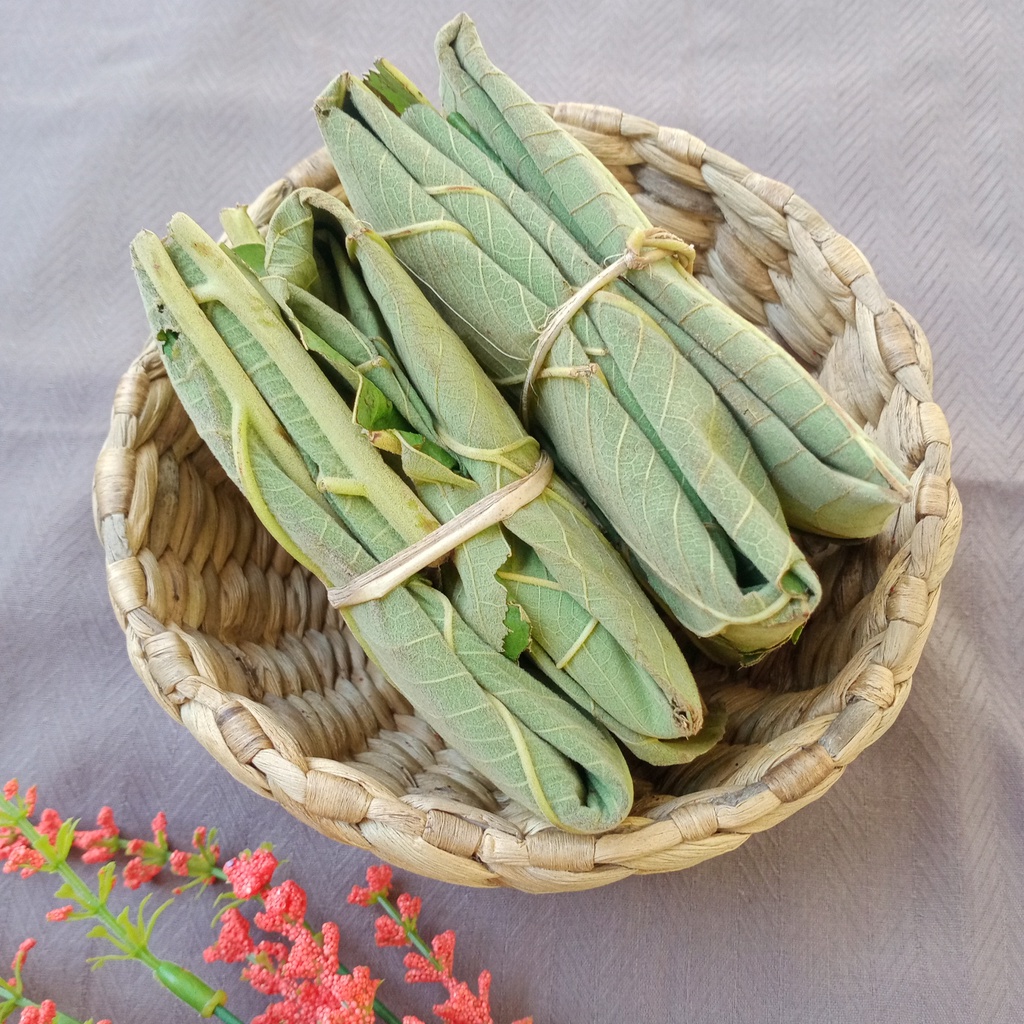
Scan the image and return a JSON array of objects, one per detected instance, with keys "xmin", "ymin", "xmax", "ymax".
[{"xmin": 0, "ymin": 781, "xmax": 530, "ymax": 1024}]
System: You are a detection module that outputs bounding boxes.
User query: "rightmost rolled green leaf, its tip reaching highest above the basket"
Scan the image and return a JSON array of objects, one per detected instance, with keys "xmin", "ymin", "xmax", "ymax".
[{"xmin": 436, "ymin": 15, "xmax": 907, "ymax": 538}]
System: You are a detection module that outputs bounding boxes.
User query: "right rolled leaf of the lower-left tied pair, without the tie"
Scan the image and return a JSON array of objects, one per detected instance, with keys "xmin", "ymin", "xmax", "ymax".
[{"xmin": 258, "ymin": 189, "xmax": 709, "ymax": 763}]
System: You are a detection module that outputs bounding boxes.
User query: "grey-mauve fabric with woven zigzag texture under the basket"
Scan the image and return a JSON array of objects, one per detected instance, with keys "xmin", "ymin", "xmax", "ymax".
[{"xmin": 0, "ymin": 0, "xmax": 1024, "ymax": 1024}]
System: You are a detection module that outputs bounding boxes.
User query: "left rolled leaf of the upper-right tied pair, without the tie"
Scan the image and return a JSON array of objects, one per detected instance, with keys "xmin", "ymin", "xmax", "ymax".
[{"xmin": 317, "ymin": 70, "xmax": 819, "ymax": 660}]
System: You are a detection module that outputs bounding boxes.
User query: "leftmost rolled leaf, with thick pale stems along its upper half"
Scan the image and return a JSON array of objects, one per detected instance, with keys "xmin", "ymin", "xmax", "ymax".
[{"xmin": 132, "ymin": 215, "xmax": 632, "ymax": 831}]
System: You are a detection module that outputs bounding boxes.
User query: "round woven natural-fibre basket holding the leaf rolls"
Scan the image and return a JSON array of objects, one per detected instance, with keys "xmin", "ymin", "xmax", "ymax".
[{"xmin": 94, "ymin": 104, "xmax": 961, "ymax": 892}]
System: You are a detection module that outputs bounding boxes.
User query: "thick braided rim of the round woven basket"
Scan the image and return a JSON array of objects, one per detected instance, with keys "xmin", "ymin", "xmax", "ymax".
[{"xmin": 93, "ymin": 103, "xmax": 961, "ymax": 892}]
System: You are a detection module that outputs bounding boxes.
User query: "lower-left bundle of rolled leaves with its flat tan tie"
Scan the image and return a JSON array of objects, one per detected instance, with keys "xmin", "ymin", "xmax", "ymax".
[{"xmin": 123, "ymin": 178, "xmax": 721, "ymax": 833}]
